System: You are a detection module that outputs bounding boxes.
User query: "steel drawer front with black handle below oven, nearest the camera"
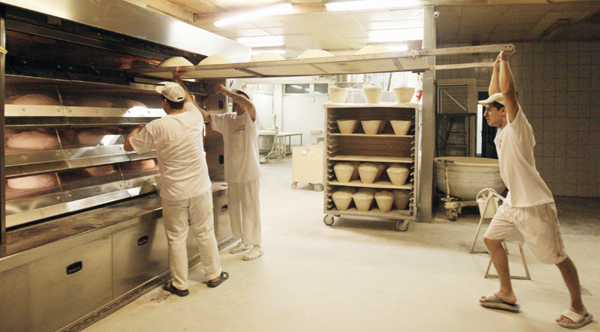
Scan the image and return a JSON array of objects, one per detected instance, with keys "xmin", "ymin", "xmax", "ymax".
[{"xmin": 29, "ymin": 236, "xmax": 113, "ymax": 331}]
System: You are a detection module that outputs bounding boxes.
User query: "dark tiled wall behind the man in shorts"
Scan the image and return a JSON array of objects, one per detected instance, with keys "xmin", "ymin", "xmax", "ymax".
[{"xmin": 438, "ymin": 41, "xmax": 600, "ymax": 197}]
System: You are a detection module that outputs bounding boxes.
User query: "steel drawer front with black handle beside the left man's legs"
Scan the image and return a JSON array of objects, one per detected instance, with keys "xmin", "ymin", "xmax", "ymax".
[{"xmin": 112, "ymin": 218, "xmax": 169, "ymax": 298}]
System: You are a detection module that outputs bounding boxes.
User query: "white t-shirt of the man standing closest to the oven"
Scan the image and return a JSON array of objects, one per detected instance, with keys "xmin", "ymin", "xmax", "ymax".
[{"xmin": 130, "ymin": 102, "xmax": 211, "ymax": 200}]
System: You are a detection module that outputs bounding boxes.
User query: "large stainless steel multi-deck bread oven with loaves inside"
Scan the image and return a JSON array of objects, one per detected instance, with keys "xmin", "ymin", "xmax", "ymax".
[{"xmin": 0, "ymin": 0, "xmax": 249, "ymax": 331}]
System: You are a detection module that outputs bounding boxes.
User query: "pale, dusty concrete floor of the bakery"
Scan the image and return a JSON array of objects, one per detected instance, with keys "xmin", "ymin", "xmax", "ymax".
[{"xmin": 86, "ymin": 159, "xmax": 600, "ymax": 332}]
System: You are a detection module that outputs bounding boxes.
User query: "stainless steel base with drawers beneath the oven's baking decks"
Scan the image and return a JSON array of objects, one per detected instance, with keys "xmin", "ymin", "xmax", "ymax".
[{"xmin": 0, "ymin": 182, "xmax": 232, "ymax": 331}]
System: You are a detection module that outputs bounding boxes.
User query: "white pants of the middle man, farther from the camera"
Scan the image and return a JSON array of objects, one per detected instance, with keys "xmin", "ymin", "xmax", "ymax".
[{"xmin": 227, "ymin": 179, "xmax": 261, "ymax": 246}]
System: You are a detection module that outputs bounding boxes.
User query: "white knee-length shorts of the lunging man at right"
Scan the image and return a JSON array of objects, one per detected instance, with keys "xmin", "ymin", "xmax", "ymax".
[{"xmin": 483, "ymin": 203, "xmax": 567, "ymax": 264}]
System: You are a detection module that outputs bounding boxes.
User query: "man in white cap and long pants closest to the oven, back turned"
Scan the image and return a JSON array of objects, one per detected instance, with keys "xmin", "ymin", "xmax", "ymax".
[{"xmin": 125, "ymin": 79, "xmax": 229, "ymax": 296}]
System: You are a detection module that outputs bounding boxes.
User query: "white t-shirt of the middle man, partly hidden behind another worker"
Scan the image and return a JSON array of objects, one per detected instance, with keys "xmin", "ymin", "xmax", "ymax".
[{"xmin": 210, "ymin": 112, "xmax": 260, "ymax": 183}]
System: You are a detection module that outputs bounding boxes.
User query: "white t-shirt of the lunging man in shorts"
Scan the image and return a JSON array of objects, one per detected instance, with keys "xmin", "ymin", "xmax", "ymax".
[{"xmin": 494, "ymin": 105, "xmax": 554, "ymax": 207}]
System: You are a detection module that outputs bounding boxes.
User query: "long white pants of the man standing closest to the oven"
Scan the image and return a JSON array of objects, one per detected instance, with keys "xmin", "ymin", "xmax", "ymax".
[{"xmin": 162, "ymin": 190, "xmax": 221, "ymax": 290}]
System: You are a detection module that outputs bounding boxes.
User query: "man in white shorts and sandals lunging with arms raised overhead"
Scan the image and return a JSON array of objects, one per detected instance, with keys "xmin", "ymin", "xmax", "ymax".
[{"xmin": 479, "ymin": 50, "xmax": 592, "ymax": 328}]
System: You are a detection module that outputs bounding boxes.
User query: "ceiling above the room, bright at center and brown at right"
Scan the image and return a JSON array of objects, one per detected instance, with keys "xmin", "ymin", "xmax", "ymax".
[{"xmin": 138, "ymin": 0, "xmax": 600, "ymax": 58}]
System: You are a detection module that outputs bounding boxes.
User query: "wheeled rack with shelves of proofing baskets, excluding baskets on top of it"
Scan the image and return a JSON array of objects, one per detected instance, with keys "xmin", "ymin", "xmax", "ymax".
[{"xmin": 324, "ymin": 103, "xmax": 418, "ymax": 231}]
